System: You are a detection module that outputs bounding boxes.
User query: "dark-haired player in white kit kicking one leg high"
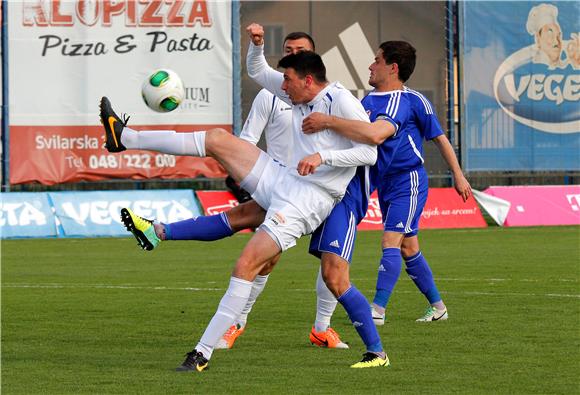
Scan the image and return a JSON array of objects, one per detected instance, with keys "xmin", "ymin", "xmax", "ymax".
[{"xmin": 100, "ymin": 24, "xmax": 388, "ymax": 371}]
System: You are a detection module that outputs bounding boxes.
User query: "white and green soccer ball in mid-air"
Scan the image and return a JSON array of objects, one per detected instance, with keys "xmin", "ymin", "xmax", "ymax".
[{"xmin": 141, "ymin": 69, "xmax": 185, "ymax": 112}]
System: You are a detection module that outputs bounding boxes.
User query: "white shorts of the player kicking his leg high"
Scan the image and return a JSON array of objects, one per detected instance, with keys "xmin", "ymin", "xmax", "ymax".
[{"xmin": 241, "ymin": 153, "xmax": 336, "ymax": 251}]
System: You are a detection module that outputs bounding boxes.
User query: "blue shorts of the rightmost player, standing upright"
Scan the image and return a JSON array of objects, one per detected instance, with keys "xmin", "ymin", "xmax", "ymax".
[{"xmin": 378, "ymin": 167, "xmax": 429, "ymax": 237}]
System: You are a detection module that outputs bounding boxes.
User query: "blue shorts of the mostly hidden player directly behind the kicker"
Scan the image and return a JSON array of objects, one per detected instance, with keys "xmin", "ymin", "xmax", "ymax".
[{"xmin": 308, "ymin": 195, "xmax": 362, "ymax": 263}]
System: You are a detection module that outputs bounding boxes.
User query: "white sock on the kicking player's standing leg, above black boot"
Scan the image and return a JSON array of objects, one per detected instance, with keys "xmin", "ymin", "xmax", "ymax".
[{"xmin": 195, "ymin": 277, "xmax": 252, "ymax": 359}]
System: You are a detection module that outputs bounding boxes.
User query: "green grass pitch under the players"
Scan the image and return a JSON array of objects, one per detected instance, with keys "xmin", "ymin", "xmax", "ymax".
[{"xmin": 1, "ymin": 227, "xmax": 580, "ymax": 394}]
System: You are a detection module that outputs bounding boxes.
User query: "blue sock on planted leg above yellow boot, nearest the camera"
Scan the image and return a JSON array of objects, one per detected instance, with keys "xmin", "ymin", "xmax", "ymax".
[{"xmin": 337, "ymin": 284, "xmax": 383, "ymax": 352}]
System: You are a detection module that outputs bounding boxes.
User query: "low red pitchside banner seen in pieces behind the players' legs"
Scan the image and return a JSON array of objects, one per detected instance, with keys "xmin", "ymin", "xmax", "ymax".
[{"xmin": 196, "ymin": 188, "xmax": 487, "ymax": 234}]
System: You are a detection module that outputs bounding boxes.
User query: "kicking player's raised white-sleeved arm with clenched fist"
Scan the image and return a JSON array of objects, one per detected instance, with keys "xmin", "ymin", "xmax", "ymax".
[{"xmin": 246, "ymin": 23, "xmax": 291, "ymax": 104}]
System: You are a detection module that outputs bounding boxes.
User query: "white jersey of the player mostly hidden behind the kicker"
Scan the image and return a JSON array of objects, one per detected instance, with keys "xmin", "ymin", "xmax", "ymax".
[{"xmin": 240, "ymin": 89, "xmax": 293, "ymax": 164}]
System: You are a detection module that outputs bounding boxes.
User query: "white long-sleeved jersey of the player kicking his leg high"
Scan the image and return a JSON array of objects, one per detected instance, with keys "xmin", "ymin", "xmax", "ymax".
[{"xmin": 246, "ymin": 43, "xmax": 377, "ymax": 198}]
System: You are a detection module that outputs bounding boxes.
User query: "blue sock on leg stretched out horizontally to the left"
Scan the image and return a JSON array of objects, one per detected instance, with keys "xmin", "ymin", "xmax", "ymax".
[{"xmin": 165, "ymin": 213, "xmax": 234, "ymax": 241}]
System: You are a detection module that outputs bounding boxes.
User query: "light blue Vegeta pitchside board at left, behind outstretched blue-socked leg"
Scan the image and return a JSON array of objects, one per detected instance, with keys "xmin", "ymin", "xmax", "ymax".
[{"xmin": 0, "ymin": 190, "xmax": 201, "ymax": 238}]
